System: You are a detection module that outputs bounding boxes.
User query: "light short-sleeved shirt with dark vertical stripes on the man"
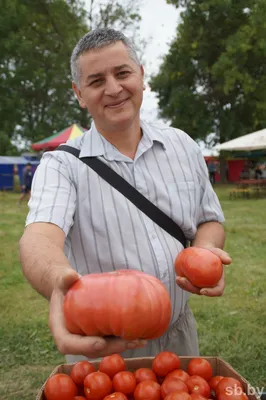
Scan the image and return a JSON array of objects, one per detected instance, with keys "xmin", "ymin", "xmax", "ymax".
[{"xmin": 26, "ymin": 121, "xmax": 224, "ymax": 324}]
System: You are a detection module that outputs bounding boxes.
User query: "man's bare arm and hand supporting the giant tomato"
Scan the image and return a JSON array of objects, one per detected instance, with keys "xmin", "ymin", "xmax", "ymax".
[{"xmin": 19, "ymin": 223, "xmax": 146, "ymax": 358}]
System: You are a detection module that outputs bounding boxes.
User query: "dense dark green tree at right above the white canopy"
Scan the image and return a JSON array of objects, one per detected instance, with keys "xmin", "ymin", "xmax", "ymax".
[{"xmin": 151, "ymin": 0, "xmax": 266, "ymax": 148}]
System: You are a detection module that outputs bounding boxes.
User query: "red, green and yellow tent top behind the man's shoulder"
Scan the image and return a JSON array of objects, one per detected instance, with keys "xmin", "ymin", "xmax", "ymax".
[{"xmin": 31, "ymin": 124, "xmax": 87, "ymax": 151}]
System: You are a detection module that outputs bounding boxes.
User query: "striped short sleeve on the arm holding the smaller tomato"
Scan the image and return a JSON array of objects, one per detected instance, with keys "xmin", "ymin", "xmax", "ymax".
[{"xmin": 195, "ymin": 149, "xmax": 225, "ymax": 225}]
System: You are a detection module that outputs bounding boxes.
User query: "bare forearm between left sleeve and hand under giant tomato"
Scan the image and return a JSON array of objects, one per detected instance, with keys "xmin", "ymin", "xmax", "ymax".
[{"xmin": 19, "ymin": 222, "xmax": 74, "ymax": 299}]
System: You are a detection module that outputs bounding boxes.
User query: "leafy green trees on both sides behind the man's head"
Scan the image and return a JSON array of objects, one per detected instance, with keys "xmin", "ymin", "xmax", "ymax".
[{"xmin": 0, "ymin": 0, "xmax": 266, "ymax": 155}]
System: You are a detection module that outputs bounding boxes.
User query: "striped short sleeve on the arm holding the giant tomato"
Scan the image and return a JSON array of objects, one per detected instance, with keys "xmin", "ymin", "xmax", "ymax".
[{"xmin": 26, "ymin": 152, "xmax": 76, "ymax": 236}]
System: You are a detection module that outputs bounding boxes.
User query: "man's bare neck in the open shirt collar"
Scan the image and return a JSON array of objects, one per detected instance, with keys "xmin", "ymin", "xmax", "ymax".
[{"xmin": 95, "ymin": 119, "xmax": 142, "ymax": 160}]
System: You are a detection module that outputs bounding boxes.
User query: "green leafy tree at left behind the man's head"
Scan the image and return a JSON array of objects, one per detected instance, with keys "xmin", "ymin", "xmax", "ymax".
[{"xmin": 0, "ymin": 0, "xmax": 143, "ymax": 154}]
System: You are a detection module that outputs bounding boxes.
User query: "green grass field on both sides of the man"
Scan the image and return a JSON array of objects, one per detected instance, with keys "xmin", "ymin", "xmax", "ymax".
[{"xmin": 0, "ymin": 187, "xmax": 266, "ymax": 400}]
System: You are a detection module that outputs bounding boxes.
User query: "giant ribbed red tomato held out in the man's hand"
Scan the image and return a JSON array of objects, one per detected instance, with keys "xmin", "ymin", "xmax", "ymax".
[{"xmin": 64, "ymin": 270, "xmax": 171, "ymax": 340}]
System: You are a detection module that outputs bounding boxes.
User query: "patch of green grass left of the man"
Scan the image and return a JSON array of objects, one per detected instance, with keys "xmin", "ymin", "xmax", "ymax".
[{"xmin": 0, "ymin": 193, "xmax": 64, "ymax": 400}]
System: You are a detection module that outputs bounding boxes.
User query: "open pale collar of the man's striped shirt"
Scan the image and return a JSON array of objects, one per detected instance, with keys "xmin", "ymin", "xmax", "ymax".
[{"xmin": 79, "ymin": 120, "xmax": 165, "ymax": 161}]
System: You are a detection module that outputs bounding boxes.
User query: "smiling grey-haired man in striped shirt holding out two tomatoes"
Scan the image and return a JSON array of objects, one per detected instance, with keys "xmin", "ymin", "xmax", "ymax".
[{"xmin": 20, "ymin": 29, "xmax": 231, "ymax": 362}]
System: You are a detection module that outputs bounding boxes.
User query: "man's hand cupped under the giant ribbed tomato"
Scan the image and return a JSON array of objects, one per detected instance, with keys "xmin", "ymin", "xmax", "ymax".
[{"xmin": 49, "ymin": 270, "xmax": 147, "ymax": 358}]
